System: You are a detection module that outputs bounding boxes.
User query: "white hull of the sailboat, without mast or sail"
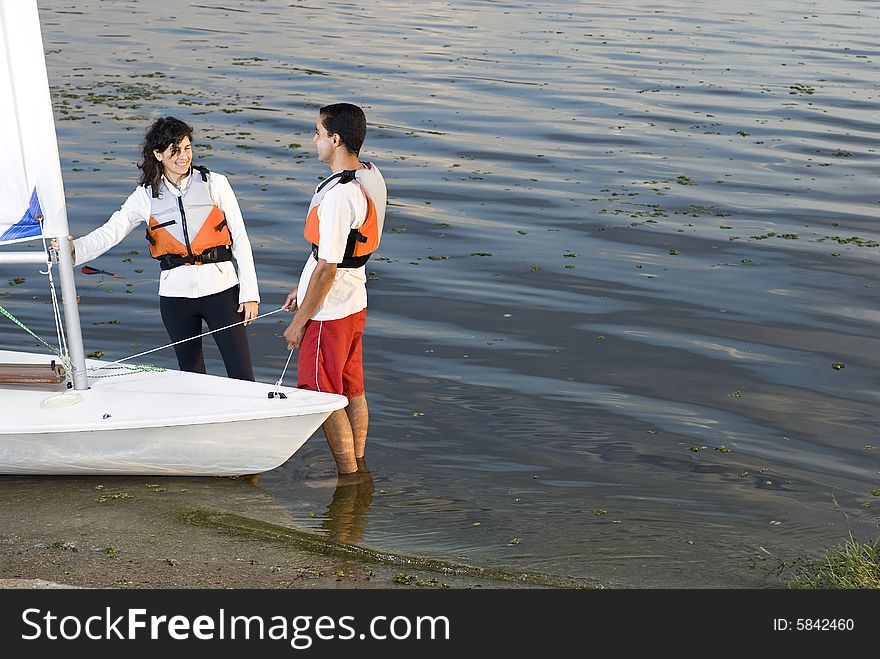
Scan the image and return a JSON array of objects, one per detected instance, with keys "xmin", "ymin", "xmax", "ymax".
[{"xmin": 0, "ymin": 350, "xmax": 348, "ymax": 476}]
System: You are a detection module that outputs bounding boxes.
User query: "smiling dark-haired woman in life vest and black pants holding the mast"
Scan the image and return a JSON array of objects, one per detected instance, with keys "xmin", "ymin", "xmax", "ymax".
[{"xmin": 73, "ymin": 117, "xmax": 260, "ymax": 380}]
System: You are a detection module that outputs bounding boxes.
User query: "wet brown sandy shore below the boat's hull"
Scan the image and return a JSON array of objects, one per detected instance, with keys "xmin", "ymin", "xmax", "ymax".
[{"xmin": 0, "ymin": 478, "xmax": 592, "ymax": 589}]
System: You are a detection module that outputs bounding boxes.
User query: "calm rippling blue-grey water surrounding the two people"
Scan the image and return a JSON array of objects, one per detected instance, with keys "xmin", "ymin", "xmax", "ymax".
[{"xmin": 0, "ymin": 0, "xmax": 880, "ymax": 587}]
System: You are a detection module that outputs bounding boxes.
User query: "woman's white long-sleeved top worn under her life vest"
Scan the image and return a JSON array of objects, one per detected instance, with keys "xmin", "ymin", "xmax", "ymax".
[{"xmin": 74, "ymin": 172, "xmax": 260, "ymax": 303}]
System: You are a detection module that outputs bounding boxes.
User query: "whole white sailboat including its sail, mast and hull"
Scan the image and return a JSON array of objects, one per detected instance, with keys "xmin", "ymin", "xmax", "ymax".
[{"xmin": 0, "ymin": 5, "xmax": 348, "ymax": 476}]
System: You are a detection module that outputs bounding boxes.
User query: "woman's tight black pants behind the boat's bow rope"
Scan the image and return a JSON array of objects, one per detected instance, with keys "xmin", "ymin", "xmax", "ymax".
[{"xmin": 159, "ymin": 286, "xmax": 254, "ymax": 380}]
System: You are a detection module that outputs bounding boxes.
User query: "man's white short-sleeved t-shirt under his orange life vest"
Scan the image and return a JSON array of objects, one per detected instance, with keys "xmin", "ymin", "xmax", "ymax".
[{"xmin": 297, "ymin": 164, "xmax": 387, "ymax": 320}]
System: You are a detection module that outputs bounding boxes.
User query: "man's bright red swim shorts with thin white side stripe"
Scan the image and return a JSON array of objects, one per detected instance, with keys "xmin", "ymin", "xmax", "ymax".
[{"xmin": 296, "ymin": 309, "xmax": 367, "ymax": 398}]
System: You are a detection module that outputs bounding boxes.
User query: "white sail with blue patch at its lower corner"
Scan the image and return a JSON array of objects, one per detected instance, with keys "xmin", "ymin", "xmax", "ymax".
[{"xmin": 0, "ymin": 0, "xmax": 67, "ymax": 244}]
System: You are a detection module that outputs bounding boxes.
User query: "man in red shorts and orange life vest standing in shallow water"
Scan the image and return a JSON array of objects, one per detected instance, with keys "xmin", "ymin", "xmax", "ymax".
[{"xmin": 284, "ymin": 103, "xmax": 387, "ymax": 474}]
